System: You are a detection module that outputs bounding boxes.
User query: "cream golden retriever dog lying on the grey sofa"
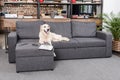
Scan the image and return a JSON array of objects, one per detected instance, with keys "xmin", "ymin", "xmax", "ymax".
[{"xmin": 39, "ymin": 24, "xmax": 69, "ymax": 45}]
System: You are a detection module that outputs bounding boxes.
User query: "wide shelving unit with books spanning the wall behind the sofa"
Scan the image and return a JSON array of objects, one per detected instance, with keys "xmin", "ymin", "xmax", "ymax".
[{"xmin": 3, "ymin": 0, "xmax": 103, "ymax": 26}]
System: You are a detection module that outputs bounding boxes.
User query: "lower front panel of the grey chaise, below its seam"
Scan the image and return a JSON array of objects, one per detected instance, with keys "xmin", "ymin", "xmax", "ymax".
[{"xmin": 16, "ymin": 56, "xmax": 54, "ymax": 72}]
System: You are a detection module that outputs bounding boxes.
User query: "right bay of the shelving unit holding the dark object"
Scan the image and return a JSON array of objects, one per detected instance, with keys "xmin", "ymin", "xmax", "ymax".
[{"xmin": 71, "ymin": 0, "xmax": 103, "ymax": 26}]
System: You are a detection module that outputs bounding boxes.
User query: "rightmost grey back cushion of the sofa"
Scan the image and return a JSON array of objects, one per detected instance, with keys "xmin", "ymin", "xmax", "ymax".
[{"xmin": 72, "ymin": 21, "xmax": 96, "ymax": 37}]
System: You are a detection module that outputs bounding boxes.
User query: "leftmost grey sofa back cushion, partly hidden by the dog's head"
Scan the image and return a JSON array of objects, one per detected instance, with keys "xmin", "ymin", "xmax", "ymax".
[{"xmin": 16, "ymin": 21, "xmax": 44, "ymax": 39}]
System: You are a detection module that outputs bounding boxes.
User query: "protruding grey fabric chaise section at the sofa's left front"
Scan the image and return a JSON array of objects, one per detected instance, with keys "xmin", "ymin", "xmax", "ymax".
[{"xmin": 16, "ymin": 42, "xmax": 54, "ymax": 72}]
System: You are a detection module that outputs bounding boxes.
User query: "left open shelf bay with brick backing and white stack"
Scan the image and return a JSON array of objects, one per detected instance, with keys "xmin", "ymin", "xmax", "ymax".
[{"xmin": 3, "ymin": 1, "xmax": 38, "ymax": 19}]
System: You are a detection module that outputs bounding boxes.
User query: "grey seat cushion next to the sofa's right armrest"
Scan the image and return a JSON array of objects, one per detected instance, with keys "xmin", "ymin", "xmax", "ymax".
[{"xmin": 74, "ymin": 38, "xmax": 106, "ymax": 48}]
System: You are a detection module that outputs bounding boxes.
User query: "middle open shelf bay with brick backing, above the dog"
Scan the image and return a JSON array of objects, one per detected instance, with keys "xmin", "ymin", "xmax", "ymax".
[{"xmin": 40, "ymin": 2, "xmax": 70, "ymax": 19}]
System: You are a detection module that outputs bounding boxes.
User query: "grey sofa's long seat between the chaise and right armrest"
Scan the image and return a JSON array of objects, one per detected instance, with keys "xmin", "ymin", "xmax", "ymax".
[{"xmin": 53, "ymin": 37, "xmax": 106, "ymax": 49}]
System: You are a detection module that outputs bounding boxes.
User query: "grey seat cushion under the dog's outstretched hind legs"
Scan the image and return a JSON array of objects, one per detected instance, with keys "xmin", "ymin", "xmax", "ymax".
[{"xmin": 52, "ymin": 39, "xmax": 79, "ymax": 49}]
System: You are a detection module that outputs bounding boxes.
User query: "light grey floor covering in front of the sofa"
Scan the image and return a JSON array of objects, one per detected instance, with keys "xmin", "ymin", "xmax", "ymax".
[{"xmin": 0, "ymin": 50, "xmax": 120, "ymax": 80}]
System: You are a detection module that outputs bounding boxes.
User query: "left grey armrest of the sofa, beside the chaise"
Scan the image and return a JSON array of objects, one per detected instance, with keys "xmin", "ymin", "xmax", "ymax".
[{"xmin": 8, "ymin": 32, "xmax": 18, "ymax": 63}]
